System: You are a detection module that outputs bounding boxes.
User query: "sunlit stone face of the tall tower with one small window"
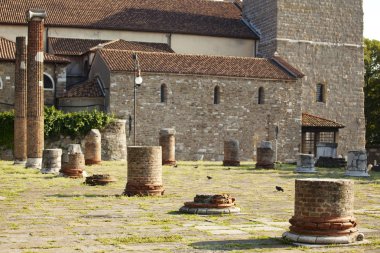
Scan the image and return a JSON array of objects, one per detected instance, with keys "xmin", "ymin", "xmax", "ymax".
[{"xmin": 245, "ymin": 0, "xmax": 365, "ymax": 155}]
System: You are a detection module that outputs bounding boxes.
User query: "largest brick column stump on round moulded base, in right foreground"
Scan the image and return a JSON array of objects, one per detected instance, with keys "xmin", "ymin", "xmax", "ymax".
[{"xmin": 283, "ymin": 178, "xmax": 364, "ymax": 244}]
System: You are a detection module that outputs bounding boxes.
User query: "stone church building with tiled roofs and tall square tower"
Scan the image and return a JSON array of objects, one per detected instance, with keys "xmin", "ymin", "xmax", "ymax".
[{"xmin": 0, "ymin": 0, "xmax": 365, "ymax": 161}]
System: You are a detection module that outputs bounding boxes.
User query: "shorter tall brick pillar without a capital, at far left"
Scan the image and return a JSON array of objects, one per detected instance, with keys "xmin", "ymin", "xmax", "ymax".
[{"xmin": 13, "ymin": 37, "xmax": 27, "ymax": 164}]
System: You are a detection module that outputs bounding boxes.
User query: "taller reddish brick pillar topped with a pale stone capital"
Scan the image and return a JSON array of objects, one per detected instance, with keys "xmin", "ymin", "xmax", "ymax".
[{"xmin": 26, "ymin": 9, "xmax": 46, "ymax": 169}]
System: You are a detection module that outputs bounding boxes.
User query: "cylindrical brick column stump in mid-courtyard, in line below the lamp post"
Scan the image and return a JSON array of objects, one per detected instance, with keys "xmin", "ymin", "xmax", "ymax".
[{"xmin": 123, "ymin": 146, "xmax": 164, "ymax": 196}]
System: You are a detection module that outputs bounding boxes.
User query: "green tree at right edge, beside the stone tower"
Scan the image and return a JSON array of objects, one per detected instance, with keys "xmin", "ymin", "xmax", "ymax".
[{"xmin": 364, "ymin": 39, "xmax": 380, "ymax": 144}]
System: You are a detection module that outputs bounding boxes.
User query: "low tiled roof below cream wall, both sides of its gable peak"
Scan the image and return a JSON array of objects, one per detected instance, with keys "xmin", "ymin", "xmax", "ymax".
[{"xmin": 49, "ymin": 37, "xmax": 174, "ymax": 55}]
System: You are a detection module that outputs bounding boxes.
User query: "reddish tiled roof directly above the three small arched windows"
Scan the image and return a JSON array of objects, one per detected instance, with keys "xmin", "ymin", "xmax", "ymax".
[{"xmin": 99, "ymin": 49, "xmax": 296, "ymax": 80}]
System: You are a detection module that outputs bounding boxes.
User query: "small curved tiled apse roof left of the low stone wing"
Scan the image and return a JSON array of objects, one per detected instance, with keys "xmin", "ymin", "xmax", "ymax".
[{"xmin": 64, "ymin": 78, "xmax": 104, "ymax": 98}]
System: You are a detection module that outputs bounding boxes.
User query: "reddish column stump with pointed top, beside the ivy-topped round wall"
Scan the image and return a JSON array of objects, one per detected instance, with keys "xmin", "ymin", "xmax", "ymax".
[{"xmin": 84, "ymin": 129, "xmax": 102, "ymax": 165}]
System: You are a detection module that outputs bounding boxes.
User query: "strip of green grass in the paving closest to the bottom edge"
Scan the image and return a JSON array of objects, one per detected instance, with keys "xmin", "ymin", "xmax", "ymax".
[{"xmin": 96, "ymin": 235, "xmax": 183, "ymax": 245}]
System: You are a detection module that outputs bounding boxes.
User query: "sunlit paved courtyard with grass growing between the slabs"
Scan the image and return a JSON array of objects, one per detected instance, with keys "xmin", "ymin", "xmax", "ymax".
[{"xmin": 0, "ymin": 161, "xmax": 380, "ymax": 253}]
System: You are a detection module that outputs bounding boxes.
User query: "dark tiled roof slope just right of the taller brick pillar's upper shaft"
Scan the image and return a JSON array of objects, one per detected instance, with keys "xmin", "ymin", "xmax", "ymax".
[{"xmin": 49, "ymin": 37, "xmax": 108, "ymax": 55}]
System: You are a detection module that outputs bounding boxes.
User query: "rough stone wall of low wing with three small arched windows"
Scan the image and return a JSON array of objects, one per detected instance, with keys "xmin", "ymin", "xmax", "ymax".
[{"xmin": 110, "ymin": 73, "xmax": 301, "ymax": 161}]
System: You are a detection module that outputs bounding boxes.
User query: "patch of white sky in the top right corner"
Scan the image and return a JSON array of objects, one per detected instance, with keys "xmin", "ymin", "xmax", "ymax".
[{"xmin": 363, "ymin": 0, "xmax": 380, "ymax": 41}]
